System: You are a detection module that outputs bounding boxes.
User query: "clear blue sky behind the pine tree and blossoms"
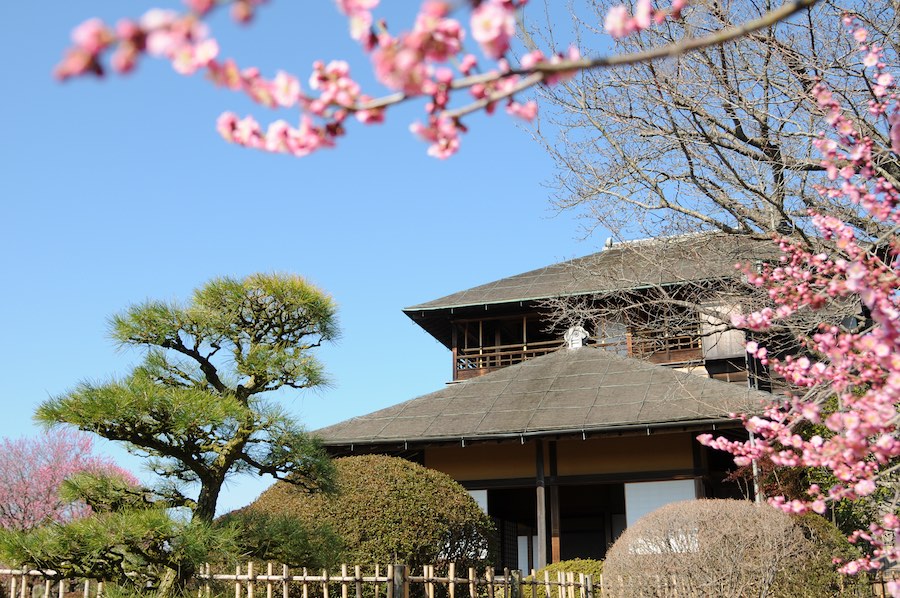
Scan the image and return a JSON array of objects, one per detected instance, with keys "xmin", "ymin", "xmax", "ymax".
[{"xmin": 0, "ymin": 0, "xmax": 603, "ymax": 510}]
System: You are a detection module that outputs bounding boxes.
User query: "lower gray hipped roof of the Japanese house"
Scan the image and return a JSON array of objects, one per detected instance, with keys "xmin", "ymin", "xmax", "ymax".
[{"xmin": 316, "ymin": 347, "xmax": 771, "ymax": 446}]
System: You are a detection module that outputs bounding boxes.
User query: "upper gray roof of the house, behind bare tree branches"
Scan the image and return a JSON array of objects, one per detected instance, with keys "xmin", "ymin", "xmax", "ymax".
[{"xmin": 403, "ymin": 233, "xmax": 778, "ymax": 313}]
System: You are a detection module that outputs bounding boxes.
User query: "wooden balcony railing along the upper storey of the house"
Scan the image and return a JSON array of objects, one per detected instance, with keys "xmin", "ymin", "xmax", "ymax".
[{"xmin": 453, "ymin": 335, "xmax": 703, "ymax": 380}]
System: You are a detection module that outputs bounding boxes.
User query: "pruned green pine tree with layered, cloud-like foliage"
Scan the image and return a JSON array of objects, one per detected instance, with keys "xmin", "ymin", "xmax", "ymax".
[{"xmin": 7, "ymin": 274, "xmax": 338, "ymax": 593}]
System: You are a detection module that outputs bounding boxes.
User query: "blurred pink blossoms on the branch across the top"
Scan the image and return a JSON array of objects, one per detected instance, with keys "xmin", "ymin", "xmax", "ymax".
[{"xmin": 56, "ymin": 0, "xmax": 686, "ymax": 158}]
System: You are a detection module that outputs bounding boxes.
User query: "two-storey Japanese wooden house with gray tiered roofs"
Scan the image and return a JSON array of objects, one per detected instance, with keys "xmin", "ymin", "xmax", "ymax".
[{"xmin": 317, "ymin": 235, "xmax": 771, "ymax": 569}]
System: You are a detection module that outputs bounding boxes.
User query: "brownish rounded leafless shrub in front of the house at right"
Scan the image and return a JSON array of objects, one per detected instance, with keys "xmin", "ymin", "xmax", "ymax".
[{"xmin": 604, "ymin": 500, "xmax": 812, "ymax": 597}]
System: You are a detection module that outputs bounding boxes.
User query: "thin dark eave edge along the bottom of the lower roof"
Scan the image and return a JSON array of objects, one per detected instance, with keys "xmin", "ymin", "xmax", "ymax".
[{"xmin": 321, "ymin": 417, "xmax": 742, "ymax": 452}]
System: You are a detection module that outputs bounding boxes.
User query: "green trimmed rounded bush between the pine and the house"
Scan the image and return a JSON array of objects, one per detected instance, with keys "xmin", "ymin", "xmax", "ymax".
[{"xmin": 247, "ymin": 455, "xmax": 493, "ymax": 571}]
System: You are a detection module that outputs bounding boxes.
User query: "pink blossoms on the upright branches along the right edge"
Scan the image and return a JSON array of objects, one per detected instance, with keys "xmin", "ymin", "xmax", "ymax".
[{"xmin": 700, "ymin": 17, "xmax": 900, "ymax": 584}]
